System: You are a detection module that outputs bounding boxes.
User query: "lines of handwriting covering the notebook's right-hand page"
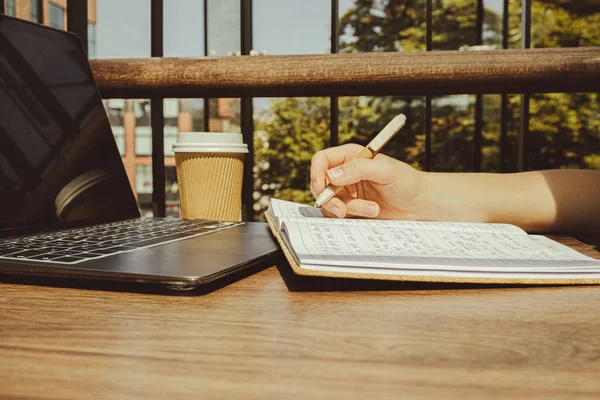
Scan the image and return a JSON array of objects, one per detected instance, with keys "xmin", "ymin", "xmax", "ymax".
[{"xmin": 285, "ymin": 221, "xmax": 579, "ymax": 260}]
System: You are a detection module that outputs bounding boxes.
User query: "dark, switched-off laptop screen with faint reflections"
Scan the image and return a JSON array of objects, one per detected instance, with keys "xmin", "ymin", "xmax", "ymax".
[{"xmin": 0, "ymin": 15, "xmax": 139, "ymax": 237}]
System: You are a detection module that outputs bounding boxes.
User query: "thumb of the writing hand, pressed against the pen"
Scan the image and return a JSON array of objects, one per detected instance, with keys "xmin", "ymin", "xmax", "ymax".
[{"xmin": 327, "ymin": 154, "xmax": 395, "ymax": 186}]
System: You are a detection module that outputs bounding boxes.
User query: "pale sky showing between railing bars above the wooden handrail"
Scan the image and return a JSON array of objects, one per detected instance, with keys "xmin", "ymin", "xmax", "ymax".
[{"xmin": 96, "ymin": 0, "xmax": 502, "ymax": 58}]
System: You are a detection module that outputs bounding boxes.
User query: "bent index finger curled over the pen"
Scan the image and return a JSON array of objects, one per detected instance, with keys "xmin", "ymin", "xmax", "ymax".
[{"xmin": 310, "ymin": 144, "xmax": 362, "ymax": 197}]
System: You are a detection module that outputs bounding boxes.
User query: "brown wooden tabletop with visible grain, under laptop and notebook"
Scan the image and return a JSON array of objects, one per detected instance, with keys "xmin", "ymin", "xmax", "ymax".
[{"xmin": 0, "ymin": 239, "xmax": 600, "ymax": 399}]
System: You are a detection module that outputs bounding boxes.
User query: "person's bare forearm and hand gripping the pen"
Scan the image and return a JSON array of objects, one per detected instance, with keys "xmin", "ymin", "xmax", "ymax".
[{"xmin": 311, "ymin": 144, "xmax": 600, "ymax": 238}]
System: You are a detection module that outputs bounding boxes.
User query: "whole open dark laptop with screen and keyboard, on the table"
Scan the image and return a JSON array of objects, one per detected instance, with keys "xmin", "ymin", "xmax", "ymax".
[{"xmin": 0, "ymin": 15, "xmax": 278, "ymax": 290}]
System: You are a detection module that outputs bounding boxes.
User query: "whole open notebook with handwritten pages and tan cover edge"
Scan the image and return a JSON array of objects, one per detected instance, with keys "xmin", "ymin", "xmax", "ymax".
[{"xmin": 266, "ymin": 199, "xmax": 600, "ymax": 284}]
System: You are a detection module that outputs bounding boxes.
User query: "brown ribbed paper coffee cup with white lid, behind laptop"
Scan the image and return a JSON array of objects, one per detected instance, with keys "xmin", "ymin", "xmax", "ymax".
[{"xmin": 173, "ymin": 132, "xmax": 248, "ymax": 221}]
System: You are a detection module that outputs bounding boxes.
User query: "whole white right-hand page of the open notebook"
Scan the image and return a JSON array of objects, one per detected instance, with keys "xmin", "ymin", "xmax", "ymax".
[{"xmin": 283, "ymin": 221, "xmax": 598, "ymax": 270}]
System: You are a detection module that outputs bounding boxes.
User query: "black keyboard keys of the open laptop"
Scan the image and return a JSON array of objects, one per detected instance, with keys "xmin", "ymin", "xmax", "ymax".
[{"xmin": 0, "ymin": 218, "xmax": 241, "ymax": 264}]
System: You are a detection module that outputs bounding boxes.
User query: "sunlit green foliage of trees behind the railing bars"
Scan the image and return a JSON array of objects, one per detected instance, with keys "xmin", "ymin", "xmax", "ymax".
[{"xmin": 255, "ymin": 0, "xmax": 600, "ymax": 216}]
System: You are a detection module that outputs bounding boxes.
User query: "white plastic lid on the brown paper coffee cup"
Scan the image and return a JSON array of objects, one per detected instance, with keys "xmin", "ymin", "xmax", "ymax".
[{"xmin": 173, "ymin": 132, "xmax": 248, "ymax": 153}]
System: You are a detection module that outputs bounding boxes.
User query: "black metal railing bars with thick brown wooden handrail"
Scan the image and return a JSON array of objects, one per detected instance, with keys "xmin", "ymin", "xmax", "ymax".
[{"xmin": 7, "ymin": 0, "xmax": 600, "ymax": 217}]
